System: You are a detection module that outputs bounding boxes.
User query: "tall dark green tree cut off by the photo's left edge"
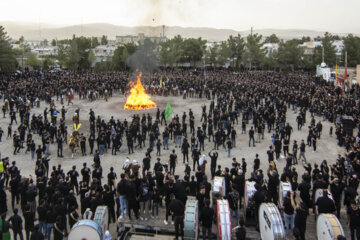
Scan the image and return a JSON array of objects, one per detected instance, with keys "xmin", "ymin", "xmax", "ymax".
[{"xmin": 0, "ymin": 26, "xmax": 18, "ymax": 73}]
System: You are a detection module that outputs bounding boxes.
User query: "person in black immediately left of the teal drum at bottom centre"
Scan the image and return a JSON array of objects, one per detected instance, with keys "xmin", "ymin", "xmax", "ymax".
[{"xmin": 169, "ymin": 195, "xmax": 185, "ymax": 240}]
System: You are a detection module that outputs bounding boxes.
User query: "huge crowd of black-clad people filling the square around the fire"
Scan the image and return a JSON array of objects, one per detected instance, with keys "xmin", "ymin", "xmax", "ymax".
[{"xmin": 0, "ymin": 70, "xmax": 360, "ymax": 240}]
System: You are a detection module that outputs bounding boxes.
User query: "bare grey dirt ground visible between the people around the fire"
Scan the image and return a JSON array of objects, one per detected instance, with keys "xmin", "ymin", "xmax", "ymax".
[{"xmin": 0, "ymin": 91, "xmax": 344, "ymax": 237}]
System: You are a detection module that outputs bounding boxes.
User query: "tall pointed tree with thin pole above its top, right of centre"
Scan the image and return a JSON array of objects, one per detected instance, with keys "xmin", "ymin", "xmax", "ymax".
[{"xmin": 244, "ymin": 33, "xmax": 265, "ymax": 70}]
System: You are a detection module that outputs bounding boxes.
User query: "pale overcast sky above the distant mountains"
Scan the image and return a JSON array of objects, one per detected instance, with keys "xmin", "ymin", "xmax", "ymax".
[{"xmin": 0, "ymin": 0, "xmax": 360, "ymax": 33}]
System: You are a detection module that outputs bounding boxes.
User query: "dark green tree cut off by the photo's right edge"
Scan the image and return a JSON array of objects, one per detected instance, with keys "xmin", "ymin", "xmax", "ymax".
[{"xmin": 343, "ymin": 34, "xmax": 360, "ymax": 67}]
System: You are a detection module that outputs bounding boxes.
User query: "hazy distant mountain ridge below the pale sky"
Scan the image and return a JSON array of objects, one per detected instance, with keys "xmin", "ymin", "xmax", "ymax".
[{"xmin": 0, "ymin": 22, "xmax": 354, "ymax": 41}]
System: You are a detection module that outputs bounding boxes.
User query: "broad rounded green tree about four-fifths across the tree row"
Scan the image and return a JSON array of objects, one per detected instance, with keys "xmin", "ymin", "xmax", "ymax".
[{"xmin": 278, "ymin": 39, "xmax": 304, "ymax": 71}]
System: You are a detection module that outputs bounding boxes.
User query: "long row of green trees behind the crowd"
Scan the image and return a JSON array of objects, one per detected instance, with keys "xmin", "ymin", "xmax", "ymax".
[{"xmin": 0, "ymin": 26, "xmax": 360, "ymax": 72}]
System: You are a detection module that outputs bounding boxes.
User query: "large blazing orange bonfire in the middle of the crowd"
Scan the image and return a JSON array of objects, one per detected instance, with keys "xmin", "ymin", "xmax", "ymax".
[{"xmin": 124, "ymin": 72, "xmax": 156, "ymax": 110}]
